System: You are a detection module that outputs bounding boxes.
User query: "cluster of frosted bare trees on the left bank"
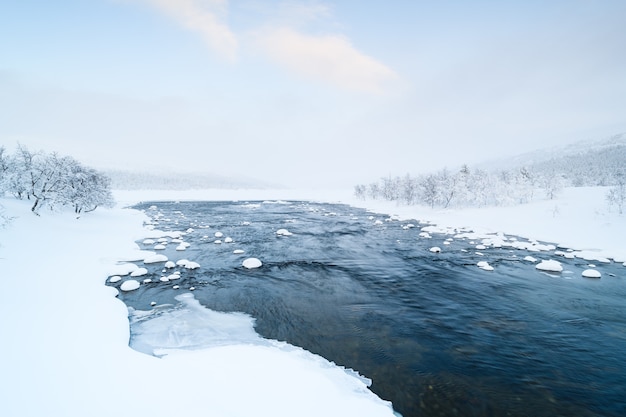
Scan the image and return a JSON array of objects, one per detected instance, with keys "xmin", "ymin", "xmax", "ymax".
[{"xmin": 0, "ymin": 145, "xmax": 114, "ymax": 214}]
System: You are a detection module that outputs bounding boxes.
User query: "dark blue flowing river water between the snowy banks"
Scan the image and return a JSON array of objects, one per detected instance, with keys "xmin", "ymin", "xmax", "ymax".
[{"xmin": 109, "ymin": 202, "xmax": 626, "ymax": 417}]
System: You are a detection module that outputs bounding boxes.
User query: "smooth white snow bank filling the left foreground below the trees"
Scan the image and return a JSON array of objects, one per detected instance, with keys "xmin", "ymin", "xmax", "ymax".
[{"xmin": 0, "ymin": 199, "xmax": 394, "ymax": 417}]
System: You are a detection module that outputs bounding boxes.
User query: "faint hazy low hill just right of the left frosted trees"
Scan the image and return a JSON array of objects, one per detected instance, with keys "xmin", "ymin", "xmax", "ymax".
[{"xmin": 102, "ymin": 170, "xmax": 277, "ymax": 190}]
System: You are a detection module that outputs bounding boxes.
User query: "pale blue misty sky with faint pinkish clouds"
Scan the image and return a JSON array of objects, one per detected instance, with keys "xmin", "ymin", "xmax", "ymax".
[{"xmin": 0, "ymin": 0, "xmax": 626, "ymax": 187}]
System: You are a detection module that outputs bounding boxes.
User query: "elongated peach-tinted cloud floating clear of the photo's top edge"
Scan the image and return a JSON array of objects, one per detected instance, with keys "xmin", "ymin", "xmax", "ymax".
[{"xmin": 256, "ymin": 27, "xmax": 398, "ymax": 93}]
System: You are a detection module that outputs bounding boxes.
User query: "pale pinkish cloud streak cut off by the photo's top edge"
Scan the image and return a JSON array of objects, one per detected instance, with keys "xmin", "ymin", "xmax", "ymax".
[{"xmin": 139, "ymin": 0, "xmax": 238, "ymax": 61}]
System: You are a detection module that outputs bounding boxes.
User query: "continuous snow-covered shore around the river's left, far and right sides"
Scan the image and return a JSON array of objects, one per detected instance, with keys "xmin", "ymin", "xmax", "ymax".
[{"xmin": 0, "ymin": 188, "xmax": 626, "ymax": 417}]
